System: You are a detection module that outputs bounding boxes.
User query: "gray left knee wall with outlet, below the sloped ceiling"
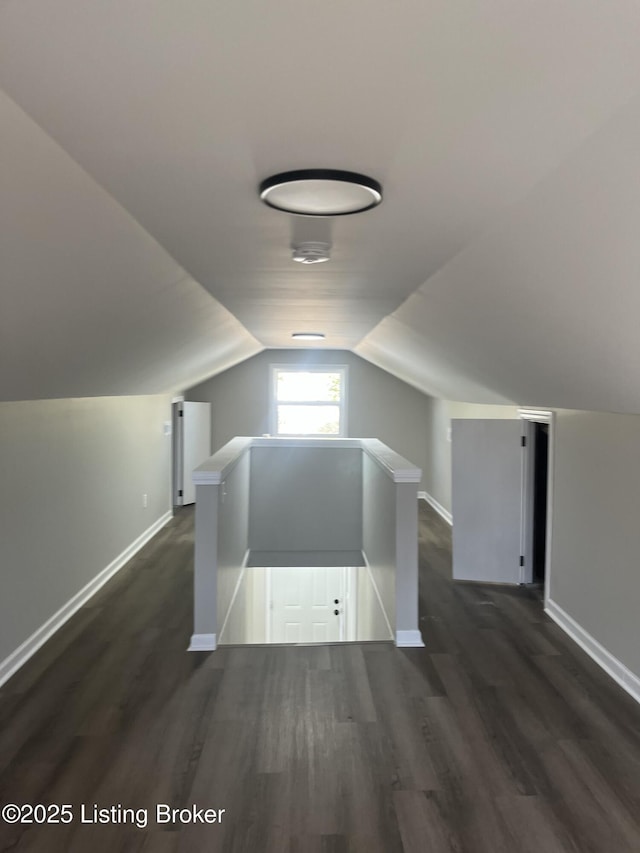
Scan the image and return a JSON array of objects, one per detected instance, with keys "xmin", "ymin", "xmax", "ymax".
[{"xmin": 0, "ymin": 396, "xmax": 171, "ymax": 661}]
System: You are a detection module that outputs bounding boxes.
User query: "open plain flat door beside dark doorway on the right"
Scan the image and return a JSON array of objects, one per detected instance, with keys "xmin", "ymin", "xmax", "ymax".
[{"xmin": 451, "ymin": 420, "xmax": 523, "ymax": 584}]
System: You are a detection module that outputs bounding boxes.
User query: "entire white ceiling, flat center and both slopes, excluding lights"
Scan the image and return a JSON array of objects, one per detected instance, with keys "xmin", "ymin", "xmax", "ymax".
[{"xmin": 0, "ymin": 0, "xmax": 640, "ymax": 411}]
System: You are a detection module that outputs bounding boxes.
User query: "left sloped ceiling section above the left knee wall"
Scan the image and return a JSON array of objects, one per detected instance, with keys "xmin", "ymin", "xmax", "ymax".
[{"xmin": 0, "ymin": 96, "xmax": 261, "ymax": 400}]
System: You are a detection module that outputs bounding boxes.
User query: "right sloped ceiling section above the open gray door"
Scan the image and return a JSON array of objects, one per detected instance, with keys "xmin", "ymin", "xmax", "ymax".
[{"xmin": 356, "ymin": 88, "xmax": 640, "ymax": 412}]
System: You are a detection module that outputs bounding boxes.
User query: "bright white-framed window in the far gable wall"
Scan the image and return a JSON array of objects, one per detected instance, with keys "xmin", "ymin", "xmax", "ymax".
[{"xmin": 271, "ymin": 365, "xmax": 347, "ymax": 436}]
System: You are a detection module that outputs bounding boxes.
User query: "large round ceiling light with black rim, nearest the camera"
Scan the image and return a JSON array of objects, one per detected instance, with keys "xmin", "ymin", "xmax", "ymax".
[{"xmin": 259, "ymin": 169, "xmax": 382, "ymax": 216}]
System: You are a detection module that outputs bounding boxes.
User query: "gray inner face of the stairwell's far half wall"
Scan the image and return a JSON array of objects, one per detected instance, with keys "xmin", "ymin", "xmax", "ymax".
[{"xmin": 249, "ymin": 447, "xmax": 363, "ymax": 551}]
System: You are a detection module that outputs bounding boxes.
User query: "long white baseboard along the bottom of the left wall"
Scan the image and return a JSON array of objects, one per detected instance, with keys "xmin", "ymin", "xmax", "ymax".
[{"xmin": 0, "ymin": 510, "xmax": 173, "ymax": 687}]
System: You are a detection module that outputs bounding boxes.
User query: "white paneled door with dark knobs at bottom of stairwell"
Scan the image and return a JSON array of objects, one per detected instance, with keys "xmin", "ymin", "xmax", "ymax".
[{"xmin": 267, "ymin": 567, "xmax": 345, "ymax": 643}]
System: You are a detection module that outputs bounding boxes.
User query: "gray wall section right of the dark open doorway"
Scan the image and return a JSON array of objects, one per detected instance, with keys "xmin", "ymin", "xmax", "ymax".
[{"xmin": 550, "ymin": 410, "xmax": 640, "ymax": 676}]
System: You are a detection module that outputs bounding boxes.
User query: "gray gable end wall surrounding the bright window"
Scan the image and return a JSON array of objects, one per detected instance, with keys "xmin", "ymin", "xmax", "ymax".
[{"xmin": 185, "ymin": 349, "xmax": 431, "ymax": 488}]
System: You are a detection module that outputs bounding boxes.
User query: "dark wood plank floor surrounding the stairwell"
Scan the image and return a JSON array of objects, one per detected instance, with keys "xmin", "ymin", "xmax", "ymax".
[{"xmin": 0, "ymin": 502, "xmax": 640, "ymax": 853}]
